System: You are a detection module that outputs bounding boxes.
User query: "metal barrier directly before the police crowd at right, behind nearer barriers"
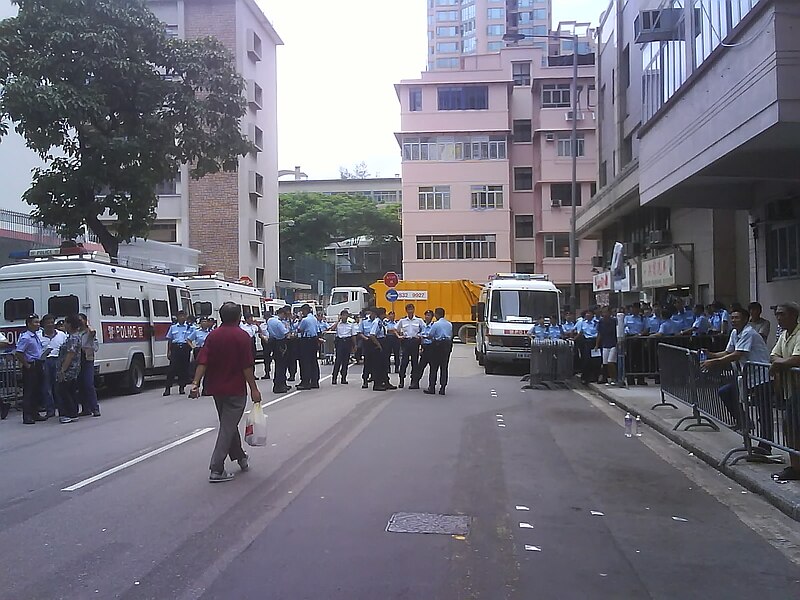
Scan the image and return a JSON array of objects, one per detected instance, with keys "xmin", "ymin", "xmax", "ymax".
[{"xmin": 620, "ymin": 335, "xmax": 728, "ymax": 380}]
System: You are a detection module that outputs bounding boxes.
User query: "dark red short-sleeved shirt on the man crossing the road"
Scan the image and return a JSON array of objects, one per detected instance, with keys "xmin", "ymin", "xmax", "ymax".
[{"xmin": 197, "ymin": 323, "xmax": 254, "ymax": 396}]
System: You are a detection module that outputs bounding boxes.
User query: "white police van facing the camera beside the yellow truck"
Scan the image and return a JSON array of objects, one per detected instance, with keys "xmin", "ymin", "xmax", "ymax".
[{"xmin": 475, "ymin": 273, "xmax": 561, "ymax": 375}]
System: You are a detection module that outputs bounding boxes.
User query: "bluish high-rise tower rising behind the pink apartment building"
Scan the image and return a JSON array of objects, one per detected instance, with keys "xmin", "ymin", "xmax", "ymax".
[{"xmin": 428, "ymin": 0, "xmax": 552, "ymax": 71}]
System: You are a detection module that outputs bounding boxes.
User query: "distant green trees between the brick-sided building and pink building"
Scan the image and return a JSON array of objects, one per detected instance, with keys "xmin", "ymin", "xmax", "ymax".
[{"xmin": 280, "ymin": 193, "xmax": 401, "ymax": 272}]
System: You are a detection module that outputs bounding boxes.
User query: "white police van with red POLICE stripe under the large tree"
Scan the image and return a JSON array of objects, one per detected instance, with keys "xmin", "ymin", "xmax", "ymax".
[{"xmin": 0, "ymin": 248, "xmax": 192, "ymax": 393}]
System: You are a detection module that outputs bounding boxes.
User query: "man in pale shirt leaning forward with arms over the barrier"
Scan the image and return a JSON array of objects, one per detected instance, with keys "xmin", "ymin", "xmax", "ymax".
[{"xmin": 701, "ymin": 308, "xmax": 773, "ymax": 455}]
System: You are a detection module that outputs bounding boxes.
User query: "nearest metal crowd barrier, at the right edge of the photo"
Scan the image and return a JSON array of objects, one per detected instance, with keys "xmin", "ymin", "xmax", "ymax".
[{"xmin": 722, "ymin": 363, "xmax": 800, "ymax": 465}]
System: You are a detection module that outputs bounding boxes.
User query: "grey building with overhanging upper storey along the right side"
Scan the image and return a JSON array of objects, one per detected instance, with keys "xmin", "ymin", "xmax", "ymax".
[{"xmin": 577, "ymin": 0, "xmax": 800, "ymax": 332}]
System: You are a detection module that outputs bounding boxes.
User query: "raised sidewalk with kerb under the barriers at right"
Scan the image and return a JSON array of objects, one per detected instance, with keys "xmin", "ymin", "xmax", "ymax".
[{"xmin": 589, "ymin": 384, "xmax": 800, "ymax": 521}]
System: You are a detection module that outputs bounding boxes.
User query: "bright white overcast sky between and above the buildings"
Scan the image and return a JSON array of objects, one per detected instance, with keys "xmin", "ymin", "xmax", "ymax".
[{"xmin": 0, "ymin": 0, "xmax": 608, "ymax": 212}]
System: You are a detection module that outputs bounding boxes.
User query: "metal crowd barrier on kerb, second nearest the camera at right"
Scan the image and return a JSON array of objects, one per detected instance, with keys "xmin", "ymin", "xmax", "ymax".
[{"xmin": 652, "ymin": 343, "xmax": 743, "ymax": 431}]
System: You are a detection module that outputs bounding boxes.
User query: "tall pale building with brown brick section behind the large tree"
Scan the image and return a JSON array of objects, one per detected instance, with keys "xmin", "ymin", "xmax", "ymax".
[{"xmin": 148, "ymin": 0, "xmax": 282, "ymax": 295}]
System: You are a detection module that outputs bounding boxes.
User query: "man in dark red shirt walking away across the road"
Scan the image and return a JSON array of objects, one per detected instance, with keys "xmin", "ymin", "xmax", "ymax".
[{"xmin": 189, "ymin": 302, "xmax": 261, "ymax": 483}]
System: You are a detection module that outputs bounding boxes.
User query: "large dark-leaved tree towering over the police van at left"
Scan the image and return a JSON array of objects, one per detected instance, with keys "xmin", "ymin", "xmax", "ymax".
[{"xmin": 0, "ymin": 0, "xmax": 251, "ymax": 256}]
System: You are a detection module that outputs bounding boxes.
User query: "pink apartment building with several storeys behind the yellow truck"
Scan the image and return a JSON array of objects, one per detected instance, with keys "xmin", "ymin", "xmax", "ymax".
[{"xmin": 396, "ymin": 47, "xmax": 597, "ymax": 306}]
